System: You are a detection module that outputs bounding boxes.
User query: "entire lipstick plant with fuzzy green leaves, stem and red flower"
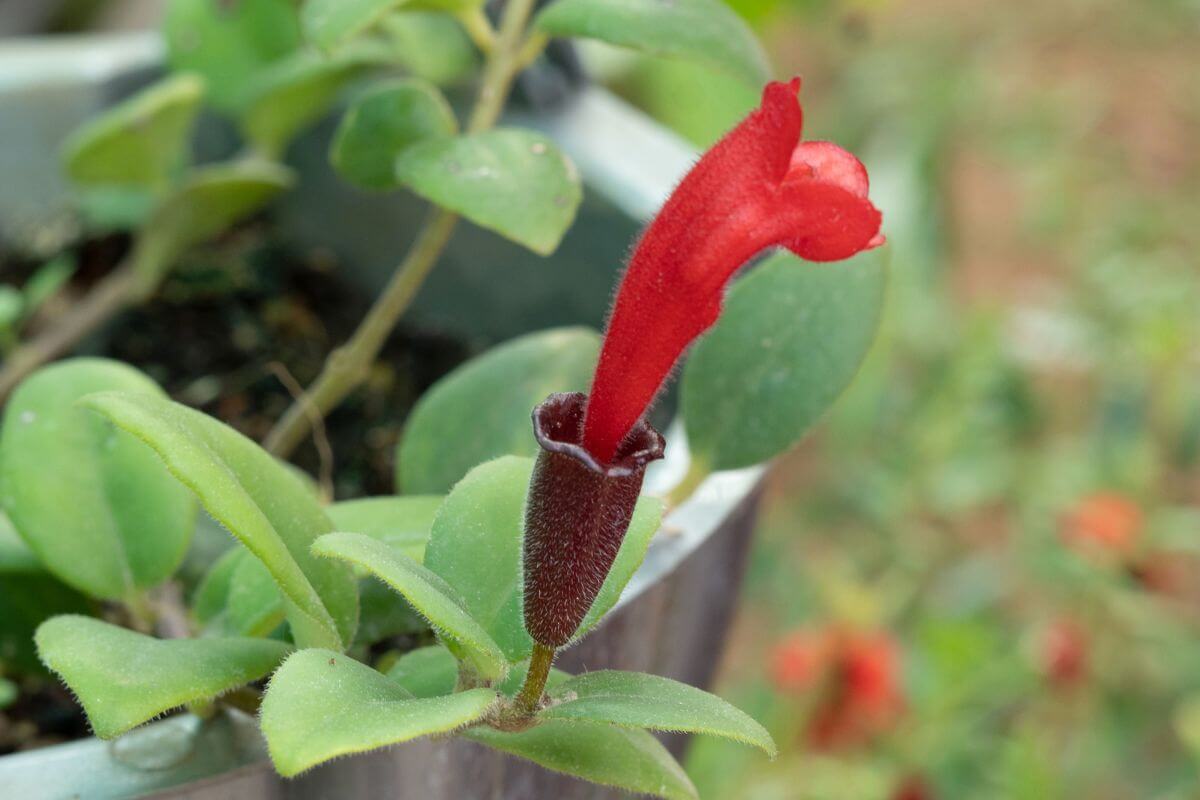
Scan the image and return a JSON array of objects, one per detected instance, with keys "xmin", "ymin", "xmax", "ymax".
[{"xmin": 0, "ymin": 0, "xmax": 883, "ymax": 798}]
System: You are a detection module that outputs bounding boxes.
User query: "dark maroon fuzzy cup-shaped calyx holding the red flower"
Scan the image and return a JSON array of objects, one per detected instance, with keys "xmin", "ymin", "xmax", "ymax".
[{"xmin": 522, "ymin": 392, "xmax": 665, "ymax": 648}]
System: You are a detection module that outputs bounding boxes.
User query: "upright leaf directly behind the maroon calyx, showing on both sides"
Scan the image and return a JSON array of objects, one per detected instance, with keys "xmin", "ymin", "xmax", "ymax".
[{"xmin": 425, "ymin": 456, "xmax": 660, "ymax": 662}]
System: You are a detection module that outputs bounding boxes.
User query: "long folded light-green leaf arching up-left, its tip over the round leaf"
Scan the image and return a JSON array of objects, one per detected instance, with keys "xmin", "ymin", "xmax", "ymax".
[{"xmin": 83, "ymin": 392, "xmax": 358, "ymax": 649}]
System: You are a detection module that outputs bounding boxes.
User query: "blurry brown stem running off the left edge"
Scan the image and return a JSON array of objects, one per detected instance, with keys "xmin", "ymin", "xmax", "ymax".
[{"xmin": 0, "ymin": 263, "xmax": 138, "ymax": 401}]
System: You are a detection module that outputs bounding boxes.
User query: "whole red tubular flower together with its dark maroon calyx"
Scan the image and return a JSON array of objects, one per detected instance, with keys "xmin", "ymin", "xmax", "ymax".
[{"xmin": 522, "ymin": 79, "xmax": 883, "ymax": 657}]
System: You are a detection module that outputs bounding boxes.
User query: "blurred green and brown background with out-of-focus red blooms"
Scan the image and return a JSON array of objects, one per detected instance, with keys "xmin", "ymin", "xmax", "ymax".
[{"xmin": 2, "ymin": 0, "xmax": 1200, "ymax": 800}]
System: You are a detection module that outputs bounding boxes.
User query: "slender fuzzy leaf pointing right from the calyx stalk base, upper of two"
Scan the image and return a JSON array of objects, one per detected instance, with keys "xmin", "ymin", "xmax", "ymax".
[{"xmin": 539, "ymin": 669, "xmax": 776, "ymax": 758}]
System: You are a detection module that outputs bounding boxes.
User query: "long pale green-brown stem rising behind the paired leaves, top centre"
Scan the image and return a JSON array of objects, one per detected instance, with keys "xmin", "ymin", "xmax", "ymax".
[{"xmin": 264, "ymin": 0, "xmax": 547, "ymax": 458}]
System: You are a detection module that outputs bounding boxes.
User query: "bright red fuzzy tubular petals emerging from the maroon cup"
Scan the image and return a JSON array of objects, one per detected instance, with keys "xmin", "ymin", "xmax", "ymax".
[{"xmin": 583, "ymin": 78, "xmax": 883, "ymax": 463}]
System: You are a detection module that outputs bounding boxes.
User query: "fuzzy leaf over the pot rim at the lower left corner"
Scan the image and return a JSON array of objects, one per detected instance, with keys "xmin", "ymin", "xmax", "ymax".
[{"xmin": 37, "ymin": 615, "xmax": 289, "ymax": 739}]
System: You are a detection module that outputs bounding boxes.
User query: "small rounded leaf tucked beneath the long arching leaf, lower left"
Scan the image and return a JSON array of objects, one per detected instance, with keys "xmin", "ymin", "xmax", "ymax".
[{"xmin": 192, "ymin": 547, "xmax": 287, "ymax": 637}]
